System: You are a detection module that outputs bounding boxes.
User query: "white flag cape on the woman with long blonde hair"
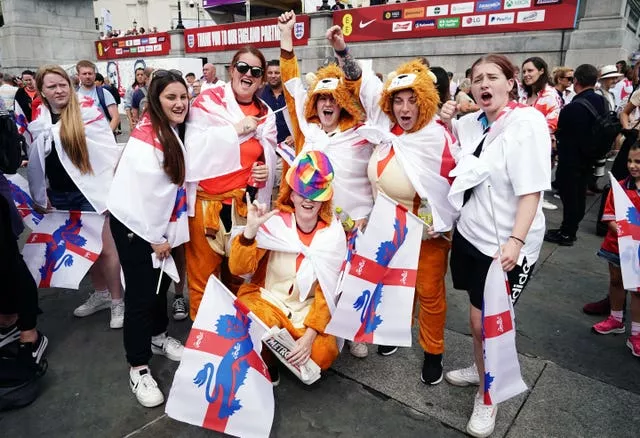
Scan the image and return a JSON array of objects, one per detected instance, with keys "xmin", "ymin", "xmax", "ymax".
[{"xmin": 27, "ymin": 96, "xmax": 122, "ymax": 213}]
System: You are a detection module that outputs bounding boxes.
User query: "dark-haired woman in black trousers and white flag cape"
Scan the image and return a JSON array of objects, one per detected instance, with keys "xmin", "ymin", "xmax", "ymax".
[{"xmin": 108, "ymin": 70, "xmax": 189, "ymax": 407}]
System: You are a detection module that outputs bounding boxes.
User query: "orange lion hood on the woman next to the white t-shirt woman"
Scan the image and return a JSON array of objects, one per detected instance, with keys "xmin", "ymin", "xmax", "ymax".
[{"xmin": 380, "ymin": 59, "xmax": 440, "ymax": 132}]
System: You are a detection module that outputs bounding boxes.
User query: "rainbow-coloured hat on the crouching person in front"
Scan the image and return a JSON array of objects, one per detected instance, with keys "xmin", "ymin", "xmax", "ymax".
[{"xmin": 285, "ymin": 151, "xmax": 333, "ymax": 202}]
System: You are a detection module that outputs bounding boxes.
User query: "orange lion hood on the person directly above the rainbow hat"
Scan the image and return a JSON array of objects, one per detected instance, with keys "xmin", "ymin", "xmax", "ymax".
[{"xmin": 304, "ymin": 64, "xmax": 366, "ymax": 131}]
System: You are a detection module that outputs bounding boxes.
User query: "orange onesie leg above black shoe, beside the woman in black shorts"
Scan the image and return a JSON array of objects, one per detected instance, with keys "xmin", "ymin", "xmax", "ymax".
[{"xmin": 416, "ymin": 238, "xmax": 451, "ymax": 354}]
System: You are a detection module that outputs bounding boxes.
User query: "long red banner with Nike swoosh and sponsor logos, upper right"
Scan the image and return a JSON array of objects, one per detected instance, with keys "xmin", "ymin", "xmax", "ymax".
[{"xmin": 333, "ymin": 0, "xmax": 578, "ymax": 42}]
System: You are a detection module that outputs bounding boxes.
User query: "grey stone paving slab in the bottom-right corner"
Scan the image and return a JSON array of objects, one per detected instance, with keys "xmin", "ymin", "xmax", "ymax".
[{"xmin": 507, "ymin": 363, "xmax": 640, "ymax": 438}]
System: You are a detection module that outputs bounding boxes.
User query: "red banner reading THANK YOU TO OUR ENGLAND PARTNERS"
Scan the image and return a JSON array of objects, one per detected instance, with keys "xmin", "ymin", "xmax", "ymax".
[{"xmin": 184, "ymin": 15, "xmax": 310, "ymax": 53}]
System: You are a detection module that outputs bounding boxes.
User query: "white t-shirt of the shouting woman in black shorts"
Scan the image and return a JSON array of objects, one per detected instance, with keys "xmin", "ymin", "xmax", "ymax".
[{"xmin": 453, "ymin": 107, "xmax": 551, "ymax": 264}]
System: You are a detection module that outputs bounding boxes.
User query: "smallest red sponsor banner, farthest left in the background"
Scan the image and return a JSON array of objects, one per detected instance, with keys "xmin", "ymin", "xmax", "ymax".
[{"xmin": 95, "ymin": 32, "xmax": 171, "ymax": 60}]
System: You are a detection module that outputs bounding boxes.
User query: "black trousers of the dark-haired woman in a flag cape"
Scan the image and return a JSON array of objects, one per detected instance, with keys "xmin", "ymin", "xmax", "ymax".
[{"xmin": 110, "ymin": 215, "xmax": 171, "ymax": 367}]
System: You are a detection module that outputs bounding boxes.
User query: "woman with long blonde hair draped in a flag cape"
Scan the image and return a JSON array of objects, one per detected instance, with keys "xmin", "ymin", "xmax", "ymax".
[{"xmin": 25, "ymin": 65, "xmax": 124, "ymax": 328}]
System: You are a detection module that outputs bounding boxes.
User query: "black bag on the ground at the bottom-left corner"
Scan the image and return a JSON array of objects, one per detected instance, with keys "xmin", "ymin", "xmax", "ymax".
[{"xmin": 0, "ymin": 357, "xmax": 48, "ymax": 411}]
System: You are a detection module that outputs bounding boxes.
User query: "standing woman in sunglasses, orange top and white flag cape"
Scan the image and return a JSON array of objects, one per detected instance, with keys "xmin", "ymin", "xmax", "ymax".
[{"xmin": 185, "ymin": 46, "xmax": 276, "ymax": 319}]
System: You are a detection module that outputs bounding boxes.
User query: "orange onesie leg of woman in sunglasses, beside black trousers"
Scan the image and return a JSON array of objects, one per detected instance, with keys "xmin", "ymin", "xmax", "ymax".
[{"xmin": 184, "ymin": 199, "xmax": 223, "ymax": 321}]
